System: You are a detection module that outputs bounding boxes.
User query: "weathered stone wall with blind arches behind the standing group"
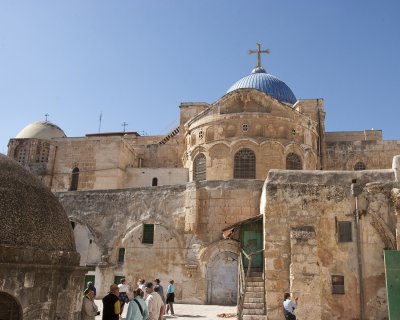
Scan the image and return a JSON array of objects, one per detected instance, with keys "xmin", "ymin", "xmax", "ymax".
[{"xmin": 57, "ymin": 180, "xmax": 263, "ymax": 303}]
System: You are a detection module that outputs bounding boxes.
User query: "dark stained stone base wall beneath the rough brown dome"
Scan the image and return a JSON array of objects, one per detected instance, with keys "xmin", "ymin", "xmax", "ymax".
[{"xmin": 0, "ymin": 246, "xmax": 87, "ymax": 320}]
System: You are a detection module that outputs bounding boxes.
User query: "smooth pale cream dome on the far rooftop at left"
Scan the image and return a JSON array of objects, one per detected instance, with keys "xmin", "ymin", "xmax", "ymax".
[{"xmin": 15, "ymin": 121, "xmax": 66, "ymax": 140}]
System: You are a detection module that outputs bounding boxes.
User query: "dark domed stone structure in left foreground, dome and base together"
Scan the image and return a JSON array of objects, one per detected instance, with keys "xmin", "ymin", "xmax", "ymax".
[{"xmin": 0, "ymin": 155, "xmax": 87, "ymax": 320}]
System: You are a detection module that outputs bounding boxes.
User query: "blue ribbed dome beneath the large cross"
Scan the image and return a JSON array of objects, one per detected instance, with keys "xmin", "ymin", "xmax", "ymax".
[{"xmin": 226, "ymin": 67, "xmax": 297, "ymax": 104}]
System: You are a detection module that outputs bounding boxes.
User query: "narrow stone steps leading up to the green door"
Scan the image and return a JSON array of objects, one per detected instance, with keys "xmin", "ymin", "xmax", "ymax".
[{"xmin": 243, "ymin": 271, "xmax": 266, "ymax": 320}]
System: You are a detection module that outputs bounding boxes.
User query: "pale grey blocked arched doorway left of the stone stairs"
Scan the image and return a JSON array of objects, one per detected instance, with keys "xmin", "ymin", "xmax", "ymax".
[{"xmin": 207, "ymin": 251, "xmax": 238, "ymax": 306}]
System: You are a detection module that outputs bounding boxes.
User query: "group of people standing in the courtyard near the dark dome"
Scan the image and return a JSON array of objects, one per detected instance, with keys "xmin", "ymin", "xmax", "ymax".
[{"xmin": 82, "ymin": 279, "xmax": 175, "ymax": 320}]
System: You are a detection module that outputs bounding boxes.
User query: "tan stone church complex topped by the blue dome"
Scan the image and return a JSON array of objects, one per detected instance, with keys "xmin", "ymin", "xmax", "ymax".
[{"xmin": 8, "ymin": 48, "xmax": 400, "ymax": 319}]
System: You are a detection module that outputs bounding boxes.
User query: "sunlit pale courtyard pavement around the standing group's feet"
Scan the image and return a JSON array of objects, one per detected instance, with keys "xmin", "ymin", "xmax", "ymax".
[{"xmin": 96, "ymin": 300, "xmax": 236, "ymax": 320}]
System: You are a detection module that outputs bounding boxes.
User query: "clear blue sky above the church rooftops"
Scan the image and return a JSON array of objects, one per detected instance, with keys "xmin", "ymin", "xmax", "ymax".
[{"xmin": 0, "ymin": 0, "xmax": 400, "ymax": 153}]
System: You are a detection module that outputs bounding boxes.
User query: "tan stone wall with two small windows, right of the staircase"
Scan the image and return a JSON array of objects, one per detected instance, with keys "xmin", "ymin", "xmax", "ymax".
[{"xmin": 261, "ymin": 170, "xmax": 398, "ymax": 320}]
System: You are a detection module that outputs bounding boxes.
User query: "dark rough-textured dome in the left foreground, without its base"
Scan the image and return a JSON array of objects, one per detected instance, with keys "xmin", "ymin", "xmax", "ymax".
[{"xmin": 0, "ymin": 154, "xmax": 75, "ymax": 252}]
